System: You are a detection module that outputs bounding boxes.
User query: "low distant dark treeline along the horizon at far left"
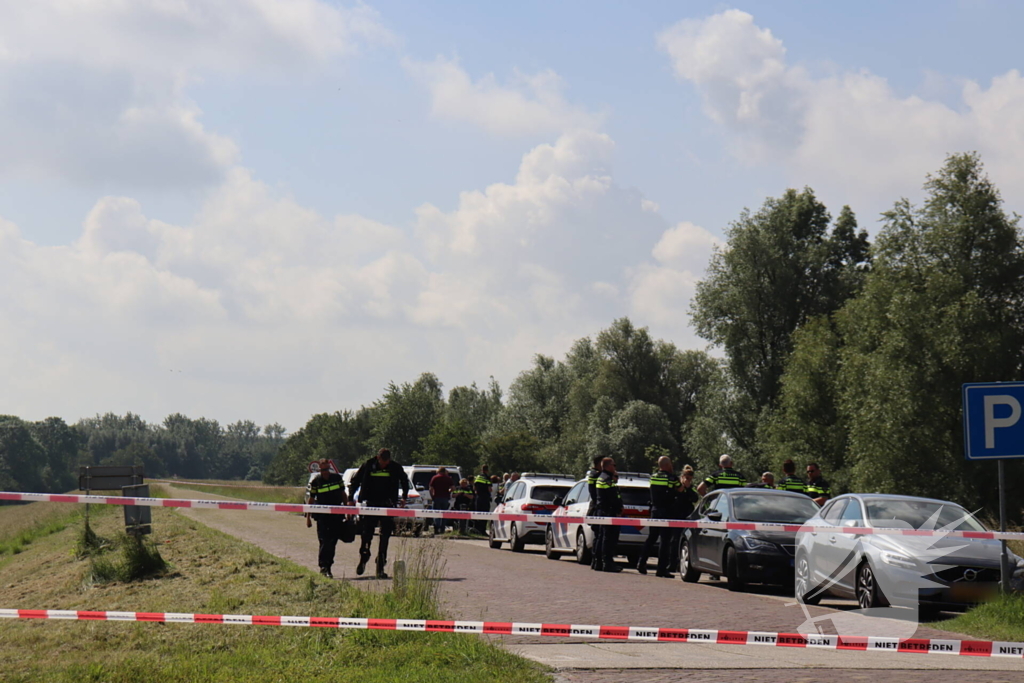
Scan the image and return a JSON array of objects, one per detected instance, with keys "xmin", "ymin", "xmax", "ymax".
[{"xmin": 0, "ymin": 413, "xmax": 285, "ymax": 492}]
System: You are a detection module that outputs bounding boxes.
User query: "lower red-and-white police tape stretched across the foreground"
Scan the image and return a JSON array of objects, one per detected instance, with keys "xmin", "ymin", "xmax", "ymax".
[{"xmin": 0, "ymin": 609, "xmax": 1024, "ymax": 659}]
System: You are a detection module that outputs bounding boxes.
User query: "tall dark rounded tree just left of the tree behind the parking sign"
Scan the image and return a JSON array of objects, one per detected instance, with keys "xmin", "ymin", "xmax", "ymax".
[{"xmin": 687, "ymin": 187, "xmax": 869, "ymax": 479}]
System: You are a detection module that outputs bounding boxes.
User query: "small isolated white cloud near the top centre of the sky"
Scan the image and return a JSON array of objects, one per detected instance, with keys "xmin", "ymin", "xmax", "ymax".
[{"xmin": 403, "ymin": 57, "xmax": 603, "ymax": 135}]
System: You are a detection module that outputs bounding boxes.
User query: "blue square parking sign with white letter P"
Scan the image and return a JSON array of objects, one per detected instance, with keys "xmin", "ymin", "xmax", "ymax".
[{"xmin": 964, "ymin": 382, "xmax": 1024, "ymax": 460}]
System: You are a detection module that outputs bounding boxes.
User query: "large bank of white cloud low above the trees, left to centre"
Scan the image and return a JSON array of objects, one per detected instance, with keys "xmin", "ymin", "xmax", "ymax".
[{"xmin": 0, "ymin": 131, "xmax": 712, "ymax": 428}]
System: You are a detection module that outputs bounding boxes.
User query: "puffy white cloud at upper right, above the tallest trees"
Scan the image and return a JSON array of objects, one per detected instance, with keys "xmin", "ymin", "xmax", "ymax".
[{"xmin": 657, "ymin": 10, "xmax": 1024, "ymax": 209}]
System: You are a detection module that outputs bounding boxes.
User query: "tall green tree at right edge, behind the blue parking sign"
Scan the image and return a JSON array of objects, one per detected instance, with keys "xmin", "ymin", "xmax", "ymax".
[{"xmin": 836, "ymin": 154, "xmax": 1024, "ymax": 510}]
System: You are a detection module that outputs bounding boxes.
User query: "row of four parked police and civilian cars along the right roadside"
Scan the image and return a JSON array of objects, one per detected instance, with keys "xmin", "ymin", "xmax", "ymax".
[{"xmin": 489, "ymin": 472, "xmax": 1024, "ymax": 609}]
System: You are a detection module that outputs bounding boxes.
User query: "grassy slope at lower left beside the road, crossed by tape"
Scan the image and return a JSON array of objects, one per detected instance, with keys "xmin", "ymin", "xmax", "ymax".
[{"xmin": 0, "ymin": 504, "xmax": 548, "ymax": 683}]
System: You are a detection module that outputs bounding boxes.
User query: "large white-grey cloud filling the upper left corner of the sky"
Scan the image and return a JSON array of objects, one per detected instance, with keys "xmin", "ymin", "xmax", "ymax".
[{"xmin": 0, "ymin": 0, "xmax": 390, "ymax": 189}]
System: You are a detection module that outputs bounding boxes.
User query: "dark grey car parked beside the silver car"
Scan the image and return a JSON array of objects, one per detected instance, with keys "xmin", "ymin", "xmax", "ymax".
[{"xmin": 679, "ymin": 488, "xmax": 818, "ymax": 591}]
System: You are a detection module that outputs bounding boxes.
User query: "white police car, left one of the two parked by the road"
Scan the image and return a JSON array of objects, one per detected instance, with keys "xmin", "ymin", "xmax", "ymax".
[{"xmin": 489, "ymin": 472, "xmax": 572, "ymax": 553}]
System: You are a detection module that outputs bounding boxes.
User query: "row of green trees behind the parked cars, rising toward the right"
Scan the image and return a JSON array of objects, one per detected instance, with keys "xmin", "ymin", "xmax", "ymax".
[{"xmin": 265, "ymin": 154, "xmax": 1024, "ymax": 519}]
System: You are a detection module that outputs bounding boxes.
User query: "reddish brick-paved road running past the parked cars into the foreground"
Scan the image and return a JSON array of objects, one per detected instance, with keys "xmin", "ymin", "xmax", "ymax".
[{"xmin": 159, "ymin": 488, "xmax": 1024, "ymax": 683}]
